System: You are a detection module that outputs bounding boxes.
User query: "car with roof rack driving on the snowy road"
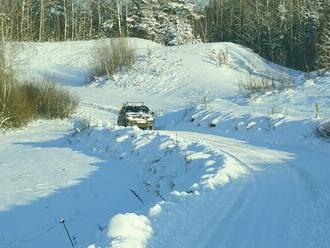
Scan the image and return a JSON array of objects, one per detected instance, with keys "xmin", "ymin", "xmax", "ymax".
[{"xmin": 117, "ymin": 102, "xmax": 155, "ymax": 129}]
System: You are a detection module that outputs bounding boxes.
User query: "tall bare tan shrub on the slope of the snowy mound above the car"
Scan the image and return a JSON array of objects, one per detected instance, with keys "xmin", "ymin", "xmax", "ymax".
[{"xmin": 92, "ymin": 38, "xmax": 136, "ymax": 76}]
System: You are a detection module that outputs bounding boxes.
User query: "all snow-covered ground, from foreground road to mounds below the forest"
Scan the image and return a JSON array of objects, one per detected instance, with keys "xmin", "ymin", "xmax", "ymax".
[{"xmin": 0, "ymin": 39, "xmax": 330, "ymax": 248}]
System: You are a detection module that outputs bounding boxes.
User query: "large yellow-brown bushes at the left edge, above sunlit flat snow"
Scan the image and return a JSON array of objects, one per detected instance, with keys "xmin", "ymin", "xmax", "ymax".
[{"xmin": 0, "ymin": 72, "xmax": 79, "ymax": 129}]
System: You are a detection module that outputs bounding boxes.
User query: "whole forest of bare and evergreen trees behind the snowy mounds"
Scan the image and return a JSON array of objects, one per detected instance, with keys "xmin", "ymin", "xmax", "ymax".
[{"xmin": 0, "ymin": 0, "xmax": 330, "ymax": 71}]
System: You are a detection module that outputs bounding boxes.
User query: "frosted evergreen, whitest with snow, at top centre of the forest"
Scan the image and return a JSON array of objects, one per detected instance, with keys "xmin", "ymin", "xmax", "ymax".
[{"xmin": 127, "ymin": 0, "xmax": 199, "ymax": 45}]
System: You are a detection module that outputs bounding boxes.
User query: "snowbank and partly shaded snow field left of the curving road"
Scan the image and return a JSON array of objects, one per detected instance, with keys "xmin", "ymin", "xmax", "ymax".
[{"xmin": 1, "ymin": 119, "xmax": 251, "ymax": 247}]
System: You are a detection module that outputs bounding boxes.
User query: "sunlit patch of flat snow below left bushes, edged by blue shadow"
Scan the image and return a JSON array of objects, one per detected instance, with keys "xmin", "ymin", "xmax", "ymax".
[{"xmin": 0, "ymin": 122, "xmax": 97, "ymax": 211}]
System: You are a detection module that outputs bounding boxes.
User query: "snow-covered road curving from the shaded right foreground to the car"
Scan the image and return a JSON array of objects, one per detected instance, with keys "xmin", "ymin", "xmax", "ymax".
[{"xmin": 47, "ymin": 97, "xmax": 330, "ymax": 248}]
